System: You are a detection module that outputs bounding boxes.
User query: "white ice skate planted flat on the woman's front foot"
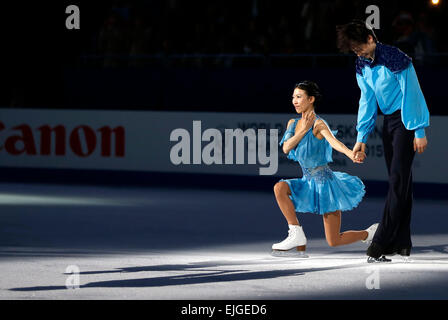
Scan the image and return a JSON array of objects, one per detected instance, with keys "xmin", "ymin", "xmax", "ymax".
[{"xmin": 272, "ymin": 225, "xmax": 308, "ymax": 258}]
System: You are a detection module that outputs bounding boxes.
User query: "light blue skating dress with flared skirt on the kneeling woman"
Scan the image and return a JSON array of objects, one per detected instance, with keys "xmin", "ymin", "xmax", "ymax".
[{"xmin": 279, "ymin": 116, "xmax": 365, "ymax": 215}]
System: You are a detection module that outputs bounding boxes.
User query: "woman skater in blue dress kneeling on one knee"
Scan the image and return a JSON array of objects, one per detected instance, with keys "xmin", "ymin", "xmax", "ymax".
[{"xmin": 272, "ymin": 81, "xmax": 378, "ymax": 257}]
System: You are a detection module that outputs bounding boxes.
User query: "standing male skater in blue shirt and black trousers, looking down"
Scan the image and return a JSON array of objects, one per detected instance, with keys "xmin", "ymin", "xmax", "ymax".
[{"xmin": 336, "ymin": 20, "xmax": 429, "ymax": 262}]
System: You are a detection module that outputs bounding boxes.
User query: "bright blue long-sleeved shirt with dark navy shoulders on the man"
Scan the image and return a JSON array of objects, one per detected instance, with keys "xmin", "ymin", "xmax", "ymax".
[{"xmin": 356, "ymin": 42, "xmax": 429, "ymax": 143}]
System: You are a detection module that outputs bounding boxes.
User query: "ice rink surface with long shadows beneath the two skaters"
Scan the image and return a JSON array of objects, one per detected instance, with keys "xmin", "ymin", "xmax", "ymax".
[{"xmin": 0, "ymin": 183, "xmax": 448, "ymax": 300}]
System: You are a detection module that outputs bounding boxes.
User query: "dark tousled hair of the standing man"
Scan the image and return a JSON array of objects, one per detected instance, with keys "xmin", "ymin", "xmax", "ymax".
[{"xmin": 336, "ymin": 20, "xmax": 378, "ymax": 53}]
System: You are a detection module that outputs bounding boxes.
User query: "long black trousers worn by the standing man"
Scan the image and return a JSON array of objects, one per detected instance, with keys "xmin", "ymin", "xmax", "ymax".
[{"xmin": 372, "ymin": 110, "xmax": 415, "ymax": 253}]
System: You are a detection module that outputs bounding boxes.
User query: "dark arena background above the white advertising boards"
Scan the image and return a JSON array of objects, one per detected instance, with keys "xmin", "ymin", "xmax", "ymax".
[{"xmin": 0, "ymin": 0, "xmax": 448, "ymax": 115}]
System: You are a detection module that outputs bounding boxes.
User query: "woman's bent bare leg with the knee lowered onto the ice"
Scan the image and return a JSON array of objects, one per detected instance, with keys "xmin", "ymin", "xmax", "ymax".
[{"xmin": 324, "ymin": 210, "xmax": 368, "ymax": 247}]
